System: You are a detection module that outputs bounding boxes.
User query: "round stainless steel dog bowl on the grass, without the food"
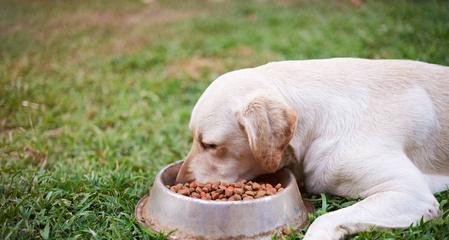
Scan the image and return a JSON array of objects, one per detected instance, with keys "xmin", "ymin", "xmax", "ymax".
[{"xmin": 136, "ymin": 161, "xmax": 307, "ymax": 239}]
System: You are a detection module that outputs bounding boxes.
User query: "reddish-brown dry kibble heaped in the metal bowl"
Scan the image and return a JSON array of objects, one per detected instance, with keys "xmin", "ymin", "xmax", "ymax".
[{"xmin": 167, "ymin": 181, "xmax": 284, "ymax": 201}]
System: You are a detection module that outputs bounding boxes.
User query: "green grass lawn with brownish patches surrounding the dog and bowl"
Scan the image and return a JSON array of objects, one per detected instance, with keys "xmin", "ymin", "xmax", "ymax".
[{"xmin": 0, "ymin": 0, "xmax": 449, "ymax": 239}]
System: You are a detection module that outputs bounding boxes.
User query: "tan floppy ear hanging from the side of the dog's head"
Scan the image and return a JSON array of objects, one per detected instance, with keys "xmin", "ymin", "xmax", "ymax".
[{"xmin": 236, "ymin": 97, "xmax": 297, "ymax": 172}]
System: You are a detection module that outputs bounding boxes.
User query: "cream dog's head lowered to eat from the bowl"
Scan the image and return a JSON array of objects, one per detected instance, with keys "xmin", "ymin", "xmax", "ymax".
[{"xmin": 177, "ymin": 76, "xmax": 297, "ymax": 182}]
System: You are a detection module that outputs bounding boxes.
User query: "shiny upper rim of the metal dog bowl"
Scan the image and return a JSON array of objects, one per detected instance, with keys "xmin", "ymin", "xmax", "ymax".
[{"xmin": 152, "ymin": 160, "xmax": 295, "ymax": 205}]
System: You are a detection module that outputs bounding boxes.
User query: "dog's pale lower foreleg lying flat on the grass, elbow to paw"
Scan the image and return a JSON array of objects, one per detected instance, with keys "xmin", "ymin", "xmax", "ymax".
[{"xmin": 304, "ymin": 192, "xmax": 439, "ymax": 240}]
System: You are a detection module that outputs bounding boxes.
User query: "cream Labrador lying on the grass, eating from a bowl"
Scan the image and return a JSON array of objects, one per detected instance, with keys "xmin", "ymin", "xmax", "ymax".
[{"xmin": 177, "ymin": 58, "xmax": 449, "ymax": 240}]
